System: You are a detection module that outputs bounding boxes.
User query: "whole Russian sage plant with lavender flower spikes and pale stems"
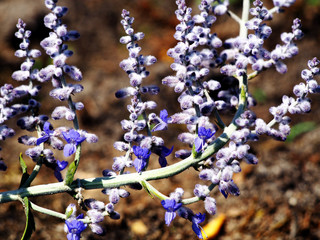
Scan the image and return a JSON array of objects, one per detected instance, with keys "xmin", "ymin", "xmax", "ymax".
[{"xmin": 0, "ymin": 0, "xmax": 320, "ymax": 239}]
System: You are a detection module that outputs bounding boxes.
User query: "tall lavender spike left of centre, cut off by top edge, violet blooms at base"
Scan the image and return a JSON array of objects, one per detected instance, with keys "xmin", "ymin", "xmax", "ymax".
[{"xmin": 13, "ymin": 1, "xmax": 97, "ymax": 181}]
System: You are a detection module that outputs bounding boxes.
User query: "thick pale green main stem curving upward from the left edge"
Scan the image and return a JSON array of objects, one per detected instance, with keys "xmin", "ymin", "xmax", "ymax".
[{"xmin": 0, "ymin": 75, "xmax": 247, "ymax": 203}]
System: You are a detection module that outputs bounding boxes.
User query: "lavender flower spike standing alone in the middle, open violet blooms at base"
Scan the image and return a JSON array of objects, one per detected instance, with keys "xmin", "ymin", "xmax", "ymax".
[{"xmin": 112, "ymin": 10, "xmax": 172, "ymax": 172}]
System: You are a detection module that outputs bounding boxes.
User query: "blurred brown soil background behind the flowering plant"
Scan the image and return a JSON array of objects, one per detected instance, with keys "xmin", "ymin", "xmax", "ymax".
[{"xmin": 0, "ymin": 0, "xmax": 320, "ymax": 240}]
